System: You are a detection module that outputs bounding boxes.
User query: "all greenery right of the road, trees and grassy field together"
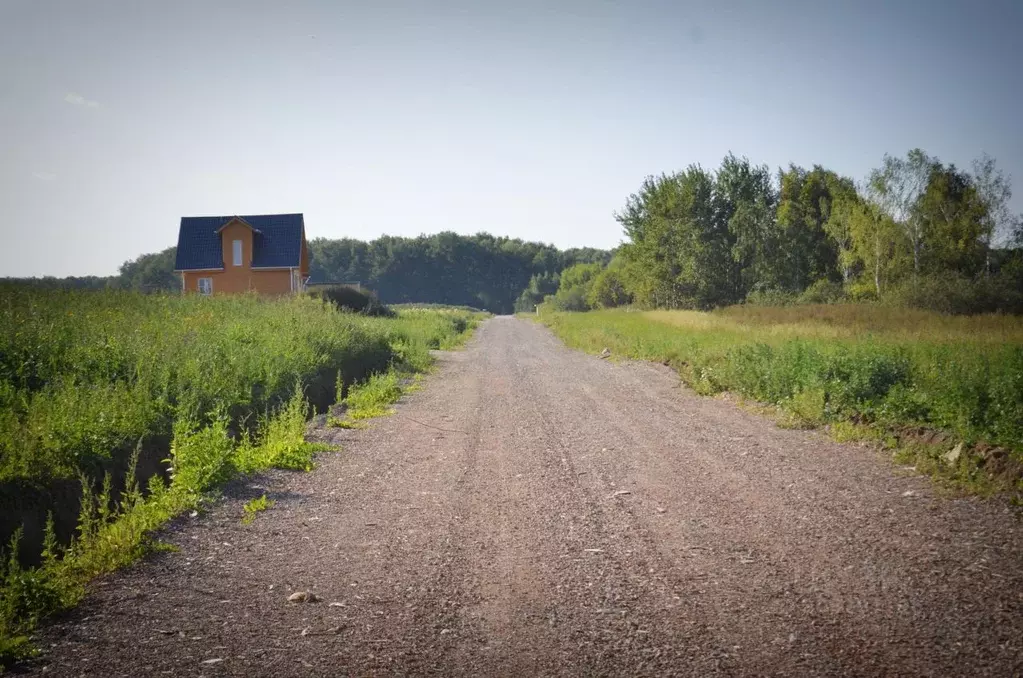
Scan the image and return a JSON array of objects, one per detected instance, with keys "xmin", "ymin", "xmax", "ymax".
[{"xmin": 536, "ymin": 149, "xmax": 1023, "ymax": 496}]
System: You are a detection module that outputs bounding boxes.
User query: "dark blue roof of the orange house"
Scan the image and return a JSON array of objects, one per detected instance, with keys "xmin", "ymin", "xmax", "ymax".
[{"xmin": 174, "ymin": 214, "xmax": 304, "ymax": 271}]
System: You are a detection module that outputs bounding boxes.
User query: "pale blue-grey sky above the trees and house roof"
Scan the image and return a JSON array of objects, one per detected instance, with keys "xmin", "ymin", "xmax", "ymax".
[{"xmin": 0, "ymin": 0, "xmax": 1023, "ymax": 276}]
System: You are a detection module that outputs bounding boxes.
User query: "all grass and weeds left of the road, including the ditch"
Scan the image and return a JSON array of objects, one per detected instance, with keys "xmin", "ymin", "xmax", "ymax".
[{"xmin": 0, "ymin": 284, "xmax": 482, "ymax": 666}]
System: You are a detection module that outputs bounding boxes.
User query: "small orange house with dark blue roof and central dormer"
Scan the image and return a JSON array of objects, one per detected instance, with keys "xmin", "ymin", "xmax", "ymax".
[{"xmin": 174, "ymin": 214, "xmax": 309, "ymax": 295}]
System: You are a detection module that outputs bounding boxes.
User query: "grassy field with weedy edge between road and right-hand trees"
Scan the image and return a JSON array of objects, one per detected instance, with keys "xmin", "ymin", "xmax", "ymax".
[{"xmin": 540, "ymin": 305, "xmax": 1023, "ymax": 497}]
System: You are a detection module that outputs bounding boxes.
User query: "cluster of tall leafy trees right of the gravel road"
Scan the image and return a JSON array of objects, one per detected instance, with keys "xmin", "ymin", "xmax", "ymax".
[{"xmin": 548, "ymin": 149, "xmax": 1023, "ymax": 312}]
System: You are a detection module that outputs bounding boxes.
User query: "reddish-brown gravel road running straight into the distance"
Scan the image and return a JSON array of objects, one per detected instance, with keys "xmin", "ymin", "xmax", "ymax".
[{"xmin": 33, "ymin": 318, "xmax": 1023, "ymax": 678}]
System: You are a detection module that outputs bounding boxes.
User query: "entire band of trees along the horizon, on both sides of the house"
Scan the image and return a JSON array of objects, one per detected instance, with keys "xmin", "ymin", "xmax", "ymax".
[{"xmin": 7, "ymin": 149, "xmax": 1023, "ymax": 313}]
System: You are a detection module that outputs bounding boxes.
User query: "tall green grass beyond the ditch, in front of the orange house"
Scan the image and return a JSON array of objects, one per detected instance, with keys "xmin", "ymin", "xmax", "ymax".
[{"xmin": 0, "ymin": 287, "xmax": 393, "ymax": 482}]
